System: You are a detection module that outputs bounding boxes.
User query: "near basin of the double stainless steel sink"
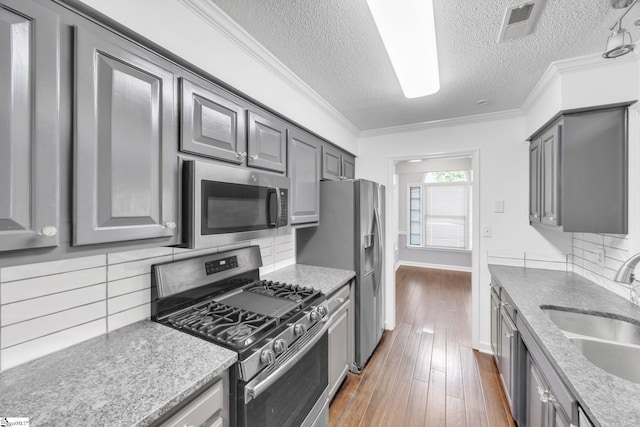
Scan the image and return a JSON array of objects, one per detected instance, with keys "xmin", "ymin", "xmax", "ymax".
[{"xmin": 571, "ymin": 338, "xmax": 640, "ymax": 383}]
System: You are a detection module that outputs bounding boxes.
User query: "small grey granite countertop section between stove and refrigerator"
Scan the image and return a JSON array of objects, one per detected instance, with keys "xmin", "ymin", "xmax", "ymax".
[{"xmin": 263, "ymin": 264, "xmax": 356, "ymax": 295}]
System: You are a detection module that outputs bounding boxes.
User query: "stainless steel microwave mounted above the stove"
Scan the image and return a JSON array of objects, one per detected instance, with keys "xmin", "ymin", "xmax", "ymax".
[{"xmin": 183, "ymin": 160, "xmax": 291, "ymax": 249}]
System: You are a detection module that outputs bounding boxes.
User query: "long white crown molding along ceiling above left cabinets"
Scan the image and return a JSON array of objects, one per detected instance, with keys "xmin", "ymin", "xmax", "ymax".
[{"xmin": 178, "ymin": 0, "xmax": 360, "ymax": 136}]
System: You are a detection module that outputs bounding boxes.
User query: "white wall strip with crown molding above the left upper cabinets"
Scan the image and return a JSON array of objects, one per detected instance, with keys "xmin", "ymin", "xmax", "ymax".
[{"xmin": 76, "ymin": 0, "xmax": 358, "ymax": 154}]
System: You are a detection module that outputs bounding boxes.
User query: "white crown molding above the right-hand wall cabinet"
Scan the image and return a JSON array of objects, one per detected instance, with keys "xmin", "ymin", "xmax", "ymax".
[{"xmin": 520, "ymin": 45, "xmax": 640, "ymax": 114}]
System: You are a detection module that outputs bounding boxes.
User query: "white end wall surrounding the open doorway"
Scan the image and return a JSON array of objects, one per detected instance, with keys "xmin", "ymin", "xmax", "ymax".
[{"xmin": 356, "ymin": 117, "xmax": 571, "ymax": 350}]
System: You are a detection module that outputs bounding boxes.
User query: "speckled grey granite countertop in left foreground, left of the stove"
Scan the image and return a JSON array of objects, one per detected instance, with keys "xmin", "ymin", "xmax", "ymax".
[{"xmin": 0, "ymin": 321, "xmax": 237, "ymax": 427}]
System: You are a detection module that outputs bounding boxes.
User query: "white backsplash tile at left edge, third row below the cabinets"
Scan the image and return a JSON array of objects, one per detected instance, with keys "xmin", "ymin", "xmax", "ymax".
[{"xmin": 0, "ymin": 283, "xmax": 106, "ymax": 327}]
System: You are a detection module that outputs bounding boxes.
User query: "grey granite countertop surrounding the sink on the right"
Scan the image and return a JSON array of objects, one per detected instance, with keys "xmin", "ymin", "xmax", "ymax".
[{"xmin": 489, "ymin": 265, "xmax": 640, "ymax": 427}]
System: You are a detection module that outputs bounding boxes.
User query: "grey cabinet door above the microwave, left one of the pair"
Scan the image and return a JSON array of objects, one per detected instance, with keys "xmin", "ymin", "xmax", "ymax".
[{"xmin": 180, "ymin": 78, "xmax": 247, "ymax": 164}]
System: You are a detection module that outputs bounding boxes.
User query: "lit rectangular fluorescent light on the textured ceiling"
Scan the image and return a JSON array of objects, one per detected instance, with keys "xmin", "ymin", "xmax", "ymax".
[{"xmin": 367, "ymin": 0, "xmax": 440, "ymax": 98}]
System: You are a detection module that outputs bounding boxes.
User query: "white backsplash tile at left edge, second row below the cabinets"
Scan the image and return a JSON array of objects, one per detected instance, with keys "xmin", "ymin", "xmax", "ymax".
[{"xmin": 0, "ymin": 267, "xmax": 107, "ymax": 304}]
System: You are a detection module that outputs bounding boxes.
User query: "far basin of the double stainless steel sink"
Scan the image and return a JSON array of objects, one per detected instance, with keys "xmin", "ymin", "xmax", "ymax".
[{"xmin": 542, "ymin": 307, "xmax": 640, "ymax": 345}]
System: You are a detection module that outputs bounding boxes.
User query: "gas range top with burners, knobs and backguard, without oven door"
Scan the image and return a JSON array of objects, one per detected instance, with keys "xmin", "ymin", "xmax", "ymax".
[{"xmin": 151, "ymin": 246, "xmax": 328, "ymax": 381}]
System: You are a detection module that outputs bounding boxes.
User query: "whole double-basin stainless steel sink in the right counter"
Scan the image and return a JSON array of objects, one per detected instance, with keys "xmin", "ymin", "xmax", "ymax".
[{"xmin": 540, "ymin": 306, "xmax": 640, "ymax": 383}]
